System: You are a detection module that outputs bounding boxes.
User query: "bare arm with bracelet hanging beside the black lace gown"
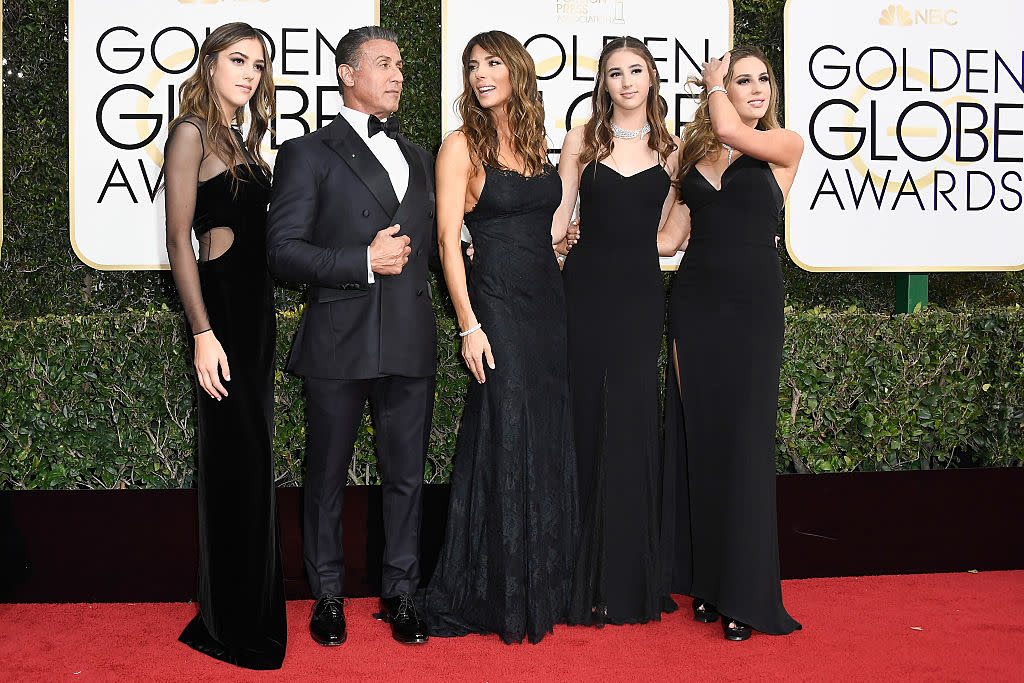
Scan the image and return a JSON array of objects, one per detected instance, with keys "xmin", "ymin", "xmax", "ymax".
[{"xmin": 435, "ymin": 131, "xmax": 495, "ymax": 384}]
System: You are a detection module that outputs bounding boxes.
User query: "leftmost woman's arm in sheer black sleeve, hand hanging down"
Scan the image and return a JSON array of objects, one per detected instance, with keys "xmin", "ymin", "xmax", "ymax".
[{"xmin": 164, "ymin": 120, "xmax": 231, "ymax": 400}]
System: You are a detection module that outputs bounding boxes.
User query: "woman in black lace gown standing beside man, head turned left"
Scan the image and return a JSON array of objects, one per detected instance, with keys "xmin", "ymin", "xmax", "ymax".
[{"xmin": 425, "ymin": 31, "xmax": 578, "ymax": 642}]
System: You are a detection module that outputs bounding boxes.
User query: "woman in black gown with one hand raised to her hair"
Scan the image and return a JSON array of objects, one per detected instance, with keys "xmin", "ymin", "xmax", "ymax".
[{"xmin": 658, "ymin": 47, "xmax": 803, "ymax": 640}]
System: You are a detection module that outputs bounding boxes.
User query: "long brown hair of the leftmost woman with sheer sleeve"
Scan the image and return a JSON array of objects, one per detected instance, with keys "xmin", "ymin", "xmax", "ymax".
[{"xmin": 168, "ymin": 22, "xmax": 276, "ymax": 181}]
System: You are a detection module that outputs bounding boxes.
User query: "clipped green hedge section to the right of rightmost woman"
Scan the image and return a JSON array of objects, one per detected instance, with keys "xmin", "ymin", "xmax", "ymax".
[{"xmin": 776, "ymin": 309, "xmax": 1024, "ymax": 472}]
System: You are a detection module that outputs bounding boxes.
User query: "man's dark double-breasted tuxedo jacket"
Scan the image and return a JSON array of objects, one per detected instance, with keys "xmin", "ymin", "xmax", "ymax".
[{"xmin": 267, "ymin": 116, "xmax": 437, "ymax": 379}]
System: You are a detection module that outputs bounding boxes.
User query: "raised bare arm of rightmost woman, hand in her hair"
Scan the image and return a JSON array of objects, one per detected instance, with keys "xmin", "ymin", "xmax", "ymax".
[{"xmin": 703, "ymin": 52, "xmax": 804, "ymax": 174}]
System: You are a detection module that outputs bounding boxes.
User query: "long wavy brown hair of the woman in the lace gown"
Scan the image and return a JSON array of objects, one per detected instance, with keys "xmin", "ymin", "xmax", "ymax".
[{"xmin": 456, "ymin": 31, "xmax": 548, "ymax": 175}]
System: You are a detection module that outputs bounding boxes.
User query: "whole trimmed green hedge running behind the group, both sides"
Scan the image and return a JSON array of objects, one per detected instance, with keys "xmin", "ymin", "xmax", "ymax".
[{"xmin": 0, "ymin": 309, "xmax": 1024, "ymax": 488}]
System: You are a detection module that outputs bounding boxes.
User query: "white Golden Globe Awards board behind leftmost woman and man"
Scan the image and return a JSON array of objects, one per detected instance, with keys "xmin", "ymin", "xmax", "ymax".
[{"xmin": 68, "ymin": 0, "xmax": 380, "ymax": 270}]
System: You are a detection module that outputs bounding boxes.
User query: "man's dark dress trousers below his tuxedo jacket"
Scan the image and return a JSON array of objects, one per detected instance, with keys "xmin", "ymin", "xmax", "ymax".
[{"xmin": 302, "ymin": 375, "xmax": 434, "ymax": 598}]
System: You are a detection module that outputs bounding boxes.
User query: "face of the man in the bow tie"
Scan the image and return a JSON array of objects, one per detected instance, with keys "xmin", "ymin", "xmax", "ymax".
[{"xmin": 338, "ymin": 38, "xmax": 404, "ymax": 119}]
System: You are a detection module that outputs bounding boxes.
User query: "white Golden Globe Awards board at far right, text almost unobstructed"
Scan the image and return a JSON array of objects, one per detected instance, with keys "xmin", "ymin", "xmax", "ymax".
[{"xmin": 785, "ymin": 0, "xmax": 1024, "ymax": 272}]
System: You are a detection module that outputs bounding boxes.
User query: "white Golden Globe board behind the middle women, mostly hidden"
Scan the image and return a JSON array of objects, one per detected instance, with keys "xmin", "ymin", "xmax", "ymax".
[{"xmin": 440, "ymin": 0, "xmax": 732, "ymax": 268}]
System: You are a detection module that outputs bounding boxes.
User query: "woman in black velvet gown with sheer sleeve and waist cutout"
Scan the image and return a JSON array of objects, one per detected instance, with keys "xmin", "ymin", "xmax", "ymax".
[{"xmin": 164, "ymin": 24, "xmax": 286, "ymax": 669}]
